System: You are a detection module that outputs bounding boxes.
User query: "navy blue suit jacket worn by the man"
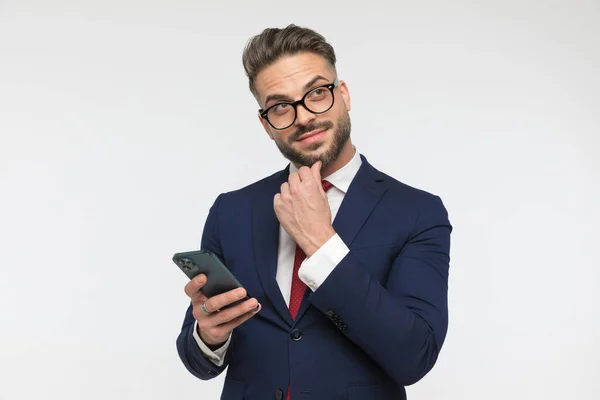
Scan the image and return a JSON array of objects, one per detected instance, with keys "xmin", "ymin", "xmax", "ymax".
[{"xmin": 177, "ymin": 155, "xmax": 452, "ymax": 400}]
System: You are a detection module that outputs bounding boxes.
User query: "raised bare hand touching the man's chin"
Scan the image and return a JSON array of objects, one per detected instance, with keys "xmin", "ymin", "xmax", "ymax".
[{"xmin": 273, "ymin": 161, "xmax": 335, "ymax": 257}]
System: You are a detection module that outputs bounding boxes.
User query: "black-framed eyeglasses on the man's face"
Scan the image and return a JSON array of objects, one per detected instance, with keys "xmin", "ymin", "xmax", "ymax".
[{"xmin": 258, "ymin": 79, "xmax": 339, "ymax": 130}]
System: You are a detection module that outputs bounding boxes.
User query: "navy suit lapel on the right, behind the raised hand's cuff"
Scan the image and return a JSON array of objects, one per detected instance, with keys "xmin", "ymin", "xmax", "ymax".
[{"xmin": 295, "ymin": 155, "xmax": 387, "ymax": 321}]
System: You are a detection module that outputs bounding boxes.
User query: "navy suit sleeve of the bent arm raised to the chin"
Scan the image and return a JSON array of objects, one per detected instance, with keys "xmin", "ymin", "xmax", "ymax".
[{"xmin": 310, "ymin": 196, "xmax": 452, "ymax": 386}]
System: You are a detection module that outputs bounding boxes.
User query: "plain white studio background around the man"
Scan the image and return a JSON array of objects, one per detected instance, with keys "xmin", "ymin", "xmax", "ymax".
[{"xmin": 0, "ymin": 0, "xmax": 600, "ymax": 400}]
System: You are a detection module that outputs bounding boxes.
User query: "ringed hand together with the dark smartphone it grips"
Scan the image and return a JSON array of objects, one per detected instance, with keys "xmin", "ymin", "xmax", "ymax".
[{"xmin": 173, "ymin": 250, "xmax": 261, "ymax": 349}]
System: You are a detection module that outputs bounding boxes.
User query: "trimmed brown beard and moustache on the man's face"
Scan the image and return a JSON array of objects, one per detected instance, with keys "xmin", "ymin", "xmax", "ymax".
[{"xmin": 275, "ymin": 110, "xmax": 351, "ymax": 168}]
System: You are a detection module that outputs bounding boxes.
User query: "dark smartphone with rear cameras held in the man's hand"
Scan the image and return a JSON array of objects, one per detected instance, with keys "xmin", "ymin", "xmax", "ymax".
[{"xmin": 173, "ymin": 250, "xmax": 249, "ymax": 309}]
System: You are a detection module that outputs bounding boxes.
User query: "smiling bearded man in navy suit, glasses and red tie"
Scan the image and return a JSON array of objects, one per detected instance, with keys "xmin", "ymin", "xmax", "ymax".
[{"xmin": 177, "ymin": 25, "xmax": 452, "ymax": 400}]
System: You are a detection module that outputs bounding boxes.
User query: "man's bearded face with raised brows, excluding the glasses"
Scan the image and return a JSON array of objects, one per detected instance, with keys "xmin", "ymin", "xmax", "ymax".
[{"xmin": 255, "ymin": 53, "xmax": 350, "ymax": 168}]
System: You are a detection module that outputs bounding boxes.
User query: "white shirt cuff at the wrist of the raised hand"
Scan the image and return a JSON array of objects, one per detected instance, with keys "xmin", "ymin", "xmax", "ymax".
[{"xmin": 298, "ymin": 233, "xmax": 350, "ymax": 292}]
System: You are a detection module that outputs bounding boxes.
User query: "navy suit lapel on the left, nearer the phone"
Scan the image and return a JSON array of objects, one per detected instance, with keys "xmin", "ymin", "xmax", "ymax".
[{"xmin": 252, "ymin": 167, "xmax": 292, "ymax": 325}]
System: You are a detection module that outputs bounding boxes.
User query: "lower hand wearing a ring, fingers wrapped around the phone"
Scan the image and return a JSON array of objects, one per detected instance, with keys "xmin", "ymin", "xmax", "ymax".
[{"xmin": 184, "ymin": 274, "xmax": 261, "ymax": 349}]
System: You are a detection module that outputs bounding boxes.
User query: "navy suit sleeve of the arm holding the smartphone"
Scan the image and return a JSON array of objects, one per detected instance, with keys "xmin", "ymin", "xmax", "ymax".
[{"xmin": 177, "ymin": 195, "xmax": 228, "ymax": 380}]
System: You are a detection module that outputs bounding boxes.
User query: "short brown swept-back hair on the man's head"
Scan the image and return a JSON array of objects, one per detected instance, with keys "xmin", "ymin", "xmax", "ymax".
[{"xmin": 242, "ymin": 24, "xmax": 336, "ymax": 97}]
